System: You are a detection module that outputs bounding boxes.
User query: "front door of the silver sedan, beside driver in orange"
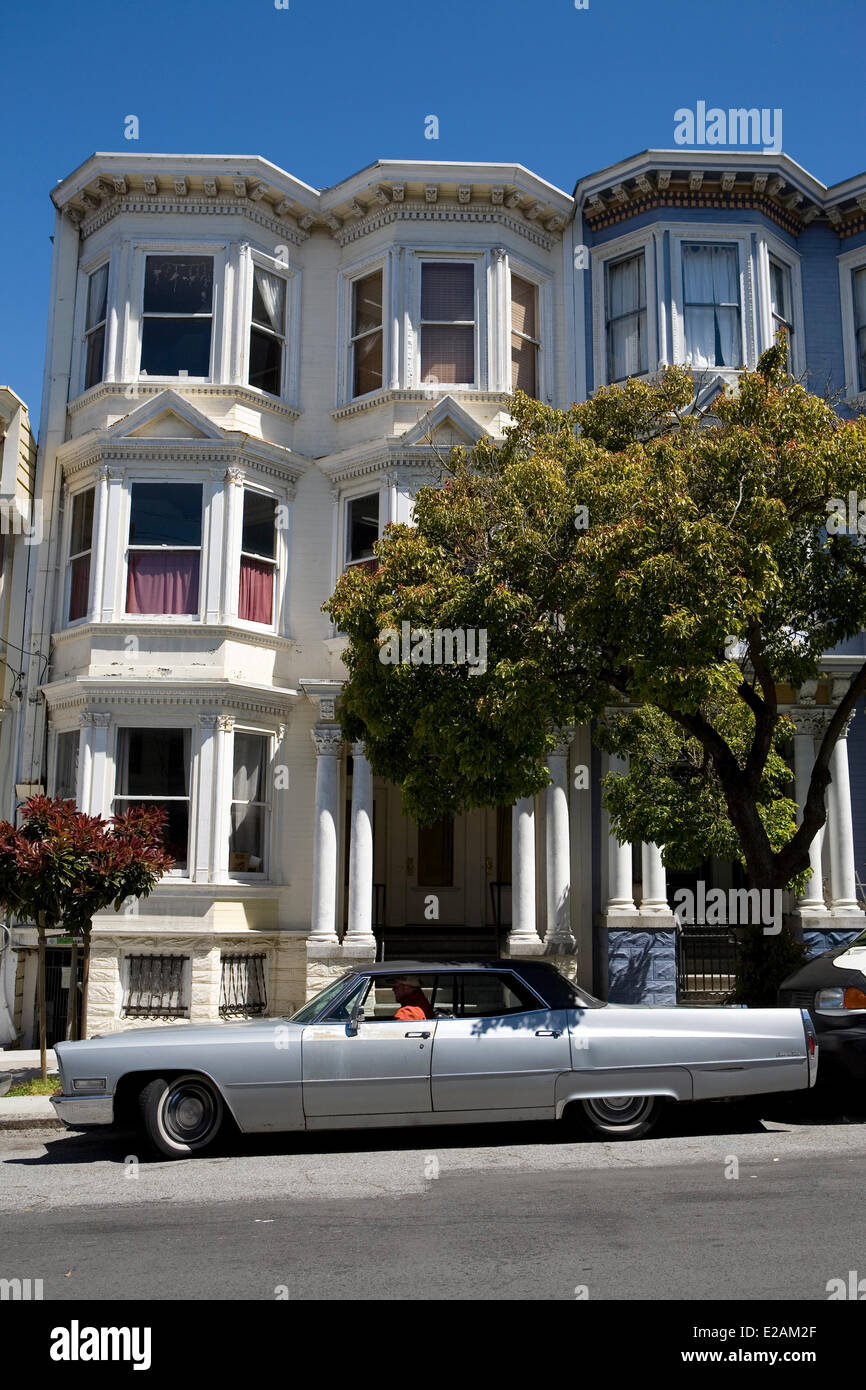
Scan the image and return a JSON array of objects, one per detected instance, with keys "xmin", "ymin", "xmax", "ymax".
[{"xmin": 302, "ymin": 977, "xmax": 436, "ymax": 1123}]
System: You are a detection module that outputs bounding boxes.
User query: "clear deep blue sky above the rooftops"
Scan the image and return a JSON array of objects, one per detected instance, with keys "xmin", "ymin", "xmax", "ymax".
[{"xmin": 0, "ymin": 0, "xmax": 866, "ymax": 421}]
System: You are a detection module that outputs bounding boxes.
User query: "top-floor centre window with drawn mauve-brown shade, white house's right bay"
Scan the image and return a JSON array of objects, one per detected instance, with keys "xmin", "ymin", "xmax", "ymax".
[{"xmin": 421, "ymin": 261, "xmax": 475, "ymax": 386}]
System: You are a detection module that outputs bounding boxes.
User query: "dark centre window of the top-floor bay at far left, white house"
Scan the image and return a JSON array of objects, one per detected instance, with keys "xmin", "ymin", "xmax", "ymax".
[{"xmin": 140, "ymin": 256, "xmax": 214, "ymax": 377}]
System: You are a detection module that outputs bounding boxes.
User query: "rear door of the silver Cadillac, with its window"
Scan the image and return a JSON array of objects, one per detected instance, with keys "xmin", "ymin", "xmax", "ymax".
[{"xmin": 432, "ymin": 970, "xmax": 571, "ymax": 1115}]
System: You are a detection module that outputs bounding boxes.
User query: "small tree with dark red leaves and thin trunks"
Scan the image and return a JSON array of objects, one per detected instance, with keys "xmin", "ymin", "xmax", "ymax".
[{"xmin": 0, "ymin": 796, "xmax": 174, "ymax": 1077}]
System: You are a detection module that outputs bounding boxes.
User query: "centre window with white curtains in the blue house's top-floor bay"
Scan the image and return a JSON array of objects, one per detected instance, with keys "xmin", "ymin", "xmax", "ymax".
[{"xmin": 683, "ymin": 242, "xmax": 742, "ymax": 368}]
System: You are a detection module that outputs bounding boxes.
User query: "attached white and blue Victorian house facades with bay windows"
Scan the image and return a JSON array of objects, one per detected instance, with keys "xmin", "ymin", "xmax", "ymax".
[{"xmin": 6, "ymin": 152, "xmax": 866, "ymax": 1037}]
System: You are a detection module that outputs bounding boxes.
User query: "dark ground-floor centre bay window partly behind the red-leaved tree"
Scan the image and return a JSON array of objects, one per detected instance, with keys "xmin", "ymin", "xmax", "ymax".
[{"xmin": 113, "ymin": 728, "xmax": 190, "ymax": 873}]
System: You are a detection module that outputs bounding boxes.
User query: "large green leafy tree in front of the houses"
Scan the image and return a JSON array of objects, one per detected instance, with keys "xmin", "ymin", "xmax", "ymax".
[{"xmin": 325, "ymin": 338, "xmax": 866, "ymax": 988}]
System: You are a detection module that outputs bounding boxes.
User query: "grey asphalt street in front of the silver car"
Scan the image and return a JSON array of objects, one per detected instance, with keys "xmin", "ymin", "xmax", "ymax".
[{"xmin": 0, "ymin": 1106, "xmax": 866, "ymax": 1301}]
